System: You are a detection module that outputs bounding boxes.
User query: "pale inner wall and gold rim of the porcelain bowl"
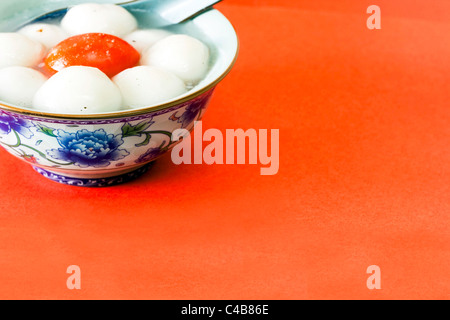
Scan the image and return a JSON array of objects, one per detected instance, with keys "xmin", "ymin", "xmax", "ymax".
[{"xmin": 0, "ymin": 0, "xmax": 238, "ymax": 118}]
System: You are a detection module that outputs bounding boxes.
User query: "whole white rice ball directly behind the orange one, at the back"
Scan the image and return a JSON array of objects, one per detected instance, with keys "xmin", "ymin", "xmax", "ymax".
[{"xmin": 61, "ymin": 3, "xmax": 138, "ymax": 37}]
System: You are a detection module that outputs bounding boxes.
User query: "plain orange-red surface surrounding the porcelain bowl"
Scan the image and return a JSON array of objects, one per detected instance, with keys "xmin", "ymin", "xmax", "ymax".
[{"xmin": 0, "ymin": 0, "xmax": 450, "ymax": 299}]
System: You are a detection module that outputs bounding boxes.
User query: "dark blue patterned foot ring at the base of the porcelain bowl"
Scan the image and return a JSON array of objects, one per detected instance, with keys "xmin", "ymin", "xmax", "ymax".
[{"xmin": 33, "ymin": 162, "xmax": 153, "ymax": 187}]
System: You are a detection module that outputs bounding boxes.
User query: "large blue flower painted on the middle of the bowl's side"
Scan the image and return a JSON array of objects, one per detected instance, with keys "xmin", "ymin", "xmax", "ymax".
[{"xmin": 47, "ymin": 129, "xmax": 129, "ymax": 168}]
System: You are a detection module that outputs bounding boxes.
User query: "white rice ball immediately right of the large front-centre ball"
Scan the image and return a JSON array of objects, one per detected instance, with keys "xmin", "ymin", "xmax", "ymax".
[{"xmin": 113, "ymin": 66, "xmax": 186, "ymax": 108}]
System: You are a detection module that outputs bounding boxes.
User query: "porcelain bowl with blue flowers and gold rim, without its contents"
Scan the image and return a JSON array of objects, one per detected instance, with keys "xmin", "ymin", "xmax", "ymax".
[{"xmin": 0, "ymin": 0, "xmax": 238, "ymax": 186}]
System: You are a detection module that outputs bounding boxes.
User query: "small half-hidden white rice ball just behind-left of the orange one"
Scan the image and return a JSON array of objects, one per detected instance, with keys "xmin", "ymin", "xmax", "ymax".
[{"xmin": 18, "ymin": 23, "xmax": 69, "ymax": 50}]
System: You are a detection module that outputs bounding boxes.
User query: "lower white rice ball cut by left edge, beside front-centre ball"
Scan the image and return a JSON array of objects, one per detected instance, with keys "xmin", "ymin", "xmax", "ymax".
[{"xmin": 0, "ymin": 66, "xmax": 47, "ymax": 108}]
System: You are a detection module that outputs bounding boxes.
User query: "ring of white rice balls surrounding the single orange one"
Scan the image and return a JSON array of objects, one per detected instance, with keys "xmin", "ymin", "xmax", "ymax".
[{"xmin": 0, "ymin": 3, "xmax": 210, "ymax": 114}]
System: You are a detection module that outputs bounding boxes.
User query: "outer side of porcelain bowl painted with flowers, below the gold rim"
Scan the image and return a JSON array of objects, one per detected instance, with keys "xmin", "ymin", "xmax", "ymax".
[{"xmin": 0, "ymin": 88, "xmax": 214, "ymax": 186}]
